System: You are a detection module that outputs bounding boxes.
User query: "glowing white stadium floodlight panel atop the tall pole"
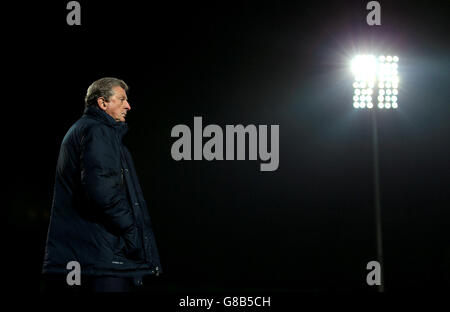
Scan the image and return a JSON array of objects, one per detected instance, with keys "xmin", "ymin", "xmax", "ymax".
[{"xmin": 351, "ymin": 55, "xmax": 399, "ymax": 109}]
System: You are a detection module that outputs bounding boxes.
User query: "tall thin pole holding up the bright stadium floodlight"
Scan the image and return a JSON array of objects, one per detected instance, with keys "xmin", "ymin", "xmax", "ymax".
[{"xmin": 372, "ymin": 109, "xmax": 384, "ymax": 292}]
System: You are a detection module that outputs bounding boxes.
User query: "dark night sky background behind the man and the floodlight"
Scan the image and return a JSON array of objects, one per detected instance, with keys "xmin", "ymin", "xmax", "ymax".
[{"xmin": 3, "ymin": 1, "xmax": 450, "ymax": 292}]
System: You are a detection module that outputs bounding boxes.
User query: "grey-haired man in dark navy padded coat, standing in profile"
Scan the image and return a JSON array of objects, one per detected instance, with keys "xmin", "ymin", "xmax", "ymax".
[{"xmin": 43, "ymin": 78, "xmax": 161, "ymax": 291}]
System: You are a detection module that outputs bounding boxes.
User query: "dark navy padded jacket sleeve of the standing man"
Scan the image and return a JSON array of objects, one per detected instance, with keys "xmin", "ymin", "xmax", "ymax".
[{"xmin": 81, "ymin": 126, "xmax": 141, "ymax": 258}]
